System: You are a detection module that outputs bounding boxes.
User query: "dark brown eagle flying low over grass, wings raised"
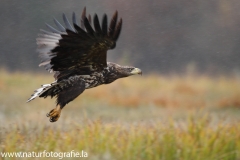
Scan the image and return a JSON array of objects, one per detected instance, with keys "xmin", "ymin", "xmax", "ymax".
[{"xmin": 27, "ymin": 8, "xmax": 142, "ymax": 122}]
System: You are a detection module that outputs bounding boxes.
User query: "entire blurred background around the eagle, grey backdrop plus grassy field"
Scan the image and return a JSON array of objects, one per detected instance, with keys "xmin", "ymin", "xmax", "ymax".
[{"xmin": 0, "ymin": 0, "xmax": 240, "ymax": 160}]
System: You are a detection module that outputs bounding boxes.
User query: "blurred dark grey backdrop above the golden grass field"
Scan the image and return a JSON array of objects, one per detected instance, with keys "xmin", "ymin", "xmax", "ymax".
[{"xmin": 0, "ymin": 0, "xmax": 240, "ymax": 74}]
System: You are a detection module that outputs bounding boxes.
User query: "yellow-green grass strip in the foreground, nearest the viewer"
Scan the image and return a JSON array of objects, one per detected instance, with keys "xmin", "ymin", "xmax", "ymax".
[{"xmin": 0, "ymin": 117, "xmax": 240, "ymax": 160}]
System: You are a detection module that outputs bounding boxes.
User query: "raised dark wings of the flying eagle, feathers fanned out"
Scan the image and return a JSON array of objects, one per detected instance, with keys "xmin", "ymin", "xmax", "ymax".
[{"xmin": 37, "ymin": 8, "xmax": 122, "ymax": 79}]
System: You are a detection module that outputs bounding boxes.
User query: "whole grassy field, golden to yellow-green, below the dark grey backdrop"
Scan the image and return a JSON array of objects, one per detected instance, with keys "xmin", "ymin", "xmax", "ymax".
[{"xmin": 0, "ymin": 70, "xmax": 240, "ymax": 160}]
